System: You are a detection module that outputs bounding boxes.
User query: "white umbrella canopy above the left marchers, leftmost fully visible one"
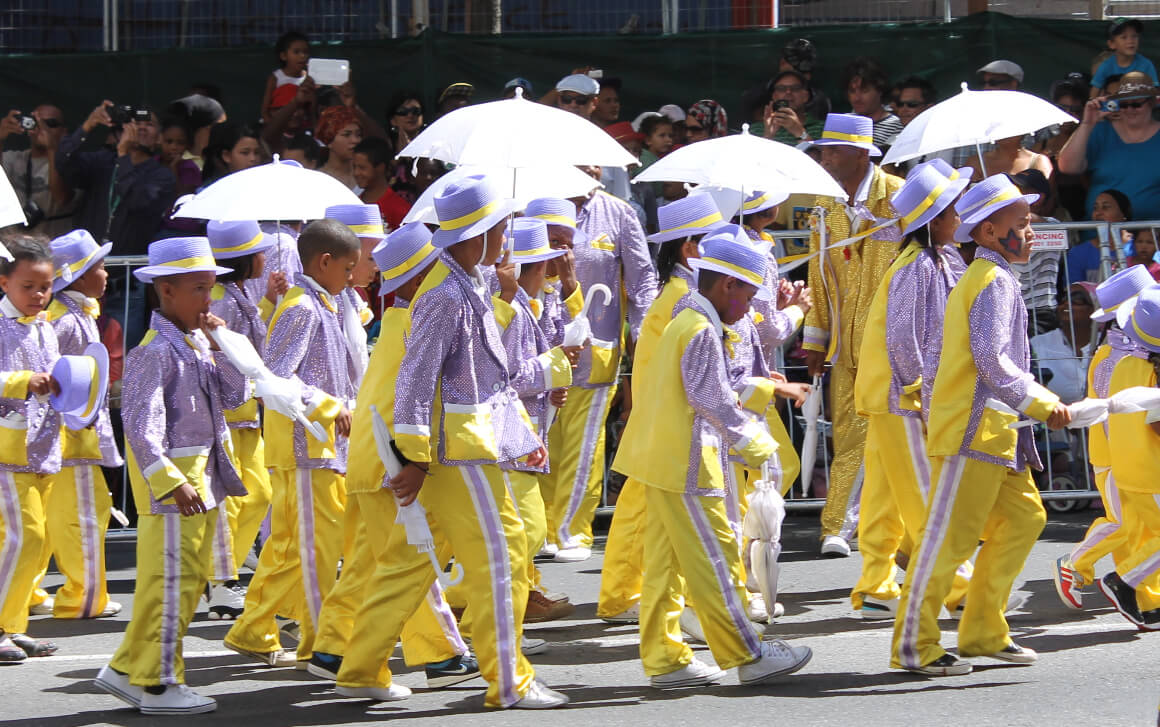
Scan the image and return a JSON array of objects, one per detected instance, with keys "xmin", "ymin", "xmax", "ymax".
[{"xmin": 174, "ymin": 159, "xmax": 362, "ymax": 221}]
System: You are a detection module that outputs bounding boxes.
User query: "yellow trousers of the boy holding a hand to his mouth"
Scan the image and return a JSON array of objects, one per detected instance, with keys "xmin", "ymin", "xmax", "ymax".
[{"xmin": 109, "ymin": 508, "xmax": 222, "ymax": 686}]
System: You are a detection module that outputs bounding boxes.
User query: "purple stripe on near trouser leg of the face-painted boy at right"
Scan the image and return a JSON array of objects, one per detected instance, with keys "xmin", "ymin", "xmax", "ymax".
[{"xmin": 898, "ymin": 455, "xmax": 966, "ymax": 667}]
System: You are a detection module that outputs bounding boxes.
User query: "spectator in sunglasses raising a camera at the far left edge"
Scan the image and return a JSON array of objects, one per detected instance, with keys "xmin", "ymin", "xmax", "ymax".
[{"xmin": 0, "ymin": 103, "xmax": 78, "ymax": 238}]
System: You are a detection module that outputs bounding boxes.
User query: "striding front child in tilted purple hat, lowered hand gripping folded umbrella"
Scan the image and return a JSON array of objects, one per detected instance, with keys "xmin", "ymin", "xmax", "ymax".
[{"xmin": 335, "ymin": 176, "xmax": 567, "ymax": 708}]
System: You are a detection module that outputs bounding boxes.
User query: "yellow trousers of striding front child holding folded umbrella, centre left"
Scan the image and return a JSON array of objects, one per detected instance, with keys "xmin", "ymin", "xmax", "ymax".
[{"xmin": 338, "ymin": 464, "xmax": 535, "ymax": 707}]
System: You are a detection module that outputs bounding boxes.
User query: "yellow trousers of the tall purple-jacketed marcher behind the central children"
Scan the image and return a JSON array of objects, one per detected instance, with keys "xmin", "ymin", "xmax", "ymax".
[{"xmin": 548, "ymin": 384, "xmax": 616, "ymax": 547}]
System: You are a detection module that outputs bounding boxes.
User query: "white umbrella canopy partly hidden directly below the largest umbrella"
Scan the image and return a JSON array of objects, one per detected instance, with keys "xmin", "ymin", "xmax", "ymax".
[{"xmin": 403, "ymin": 165, "xmax": 601, "ymax": 225}]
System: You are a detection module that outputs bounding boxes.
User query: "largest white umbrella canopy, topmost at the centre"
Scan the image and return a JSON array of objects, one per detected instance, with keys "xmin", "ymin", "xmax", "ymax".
[{"xmin": 399, "ymin": 95, "xmax": 638, "ymax": 168}]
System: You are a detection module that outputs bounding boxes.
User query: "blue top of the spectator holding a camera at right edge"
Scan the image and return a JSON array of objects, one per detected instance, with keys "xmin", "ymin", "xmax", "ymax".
[{"xmin": 1086, "ymin": 122, "xmax": 1160, "ymax": 219}]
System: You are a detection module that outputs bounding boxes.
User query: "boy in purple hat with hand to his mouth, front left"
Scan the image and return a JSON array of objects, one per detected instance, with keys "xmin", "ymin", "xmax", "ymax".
[{"xmin": 94, "ymin": 238, "xmax": 249, "ymax": 714}]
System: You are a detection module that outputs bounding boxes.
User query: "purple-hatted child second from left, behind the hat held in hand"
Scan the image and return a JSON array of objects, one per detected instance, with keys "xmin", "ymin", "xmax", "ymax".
[{"xmin": 48, "ymin": 230, "xmax": 124, "ymax": 618}]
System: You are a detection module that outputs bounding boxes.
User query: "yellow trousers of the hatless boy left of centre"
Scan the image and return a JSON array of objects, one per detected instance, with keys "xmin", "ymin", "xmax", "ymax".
[{"xmin": 225, "ymin": 470, "xmax": 346, "ymax": 661}]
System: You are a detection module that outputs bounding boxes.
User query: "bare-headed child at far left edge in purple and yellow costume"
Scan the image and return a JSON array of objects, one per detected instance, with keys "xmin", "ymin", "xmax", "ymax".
[{"xmin": 0, "ymin": 237, "xmax": 60, "ymax": 662}]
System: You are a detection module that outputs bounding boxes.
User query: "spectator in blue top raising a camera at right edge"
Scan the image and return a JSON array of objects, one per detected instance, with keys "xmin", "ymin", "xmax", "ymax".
[{"xmin": 1059, "ymin": 77, "xmax": 1160, "ymax": 223}]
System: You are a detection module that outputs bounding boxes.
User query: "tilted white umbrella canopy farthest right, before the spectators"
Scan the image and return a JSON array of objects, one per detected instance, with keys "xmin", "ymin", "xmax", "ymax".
[{"xmin": 882, "ymin": 83, "xmax": 1078, "ymax": 163}]
